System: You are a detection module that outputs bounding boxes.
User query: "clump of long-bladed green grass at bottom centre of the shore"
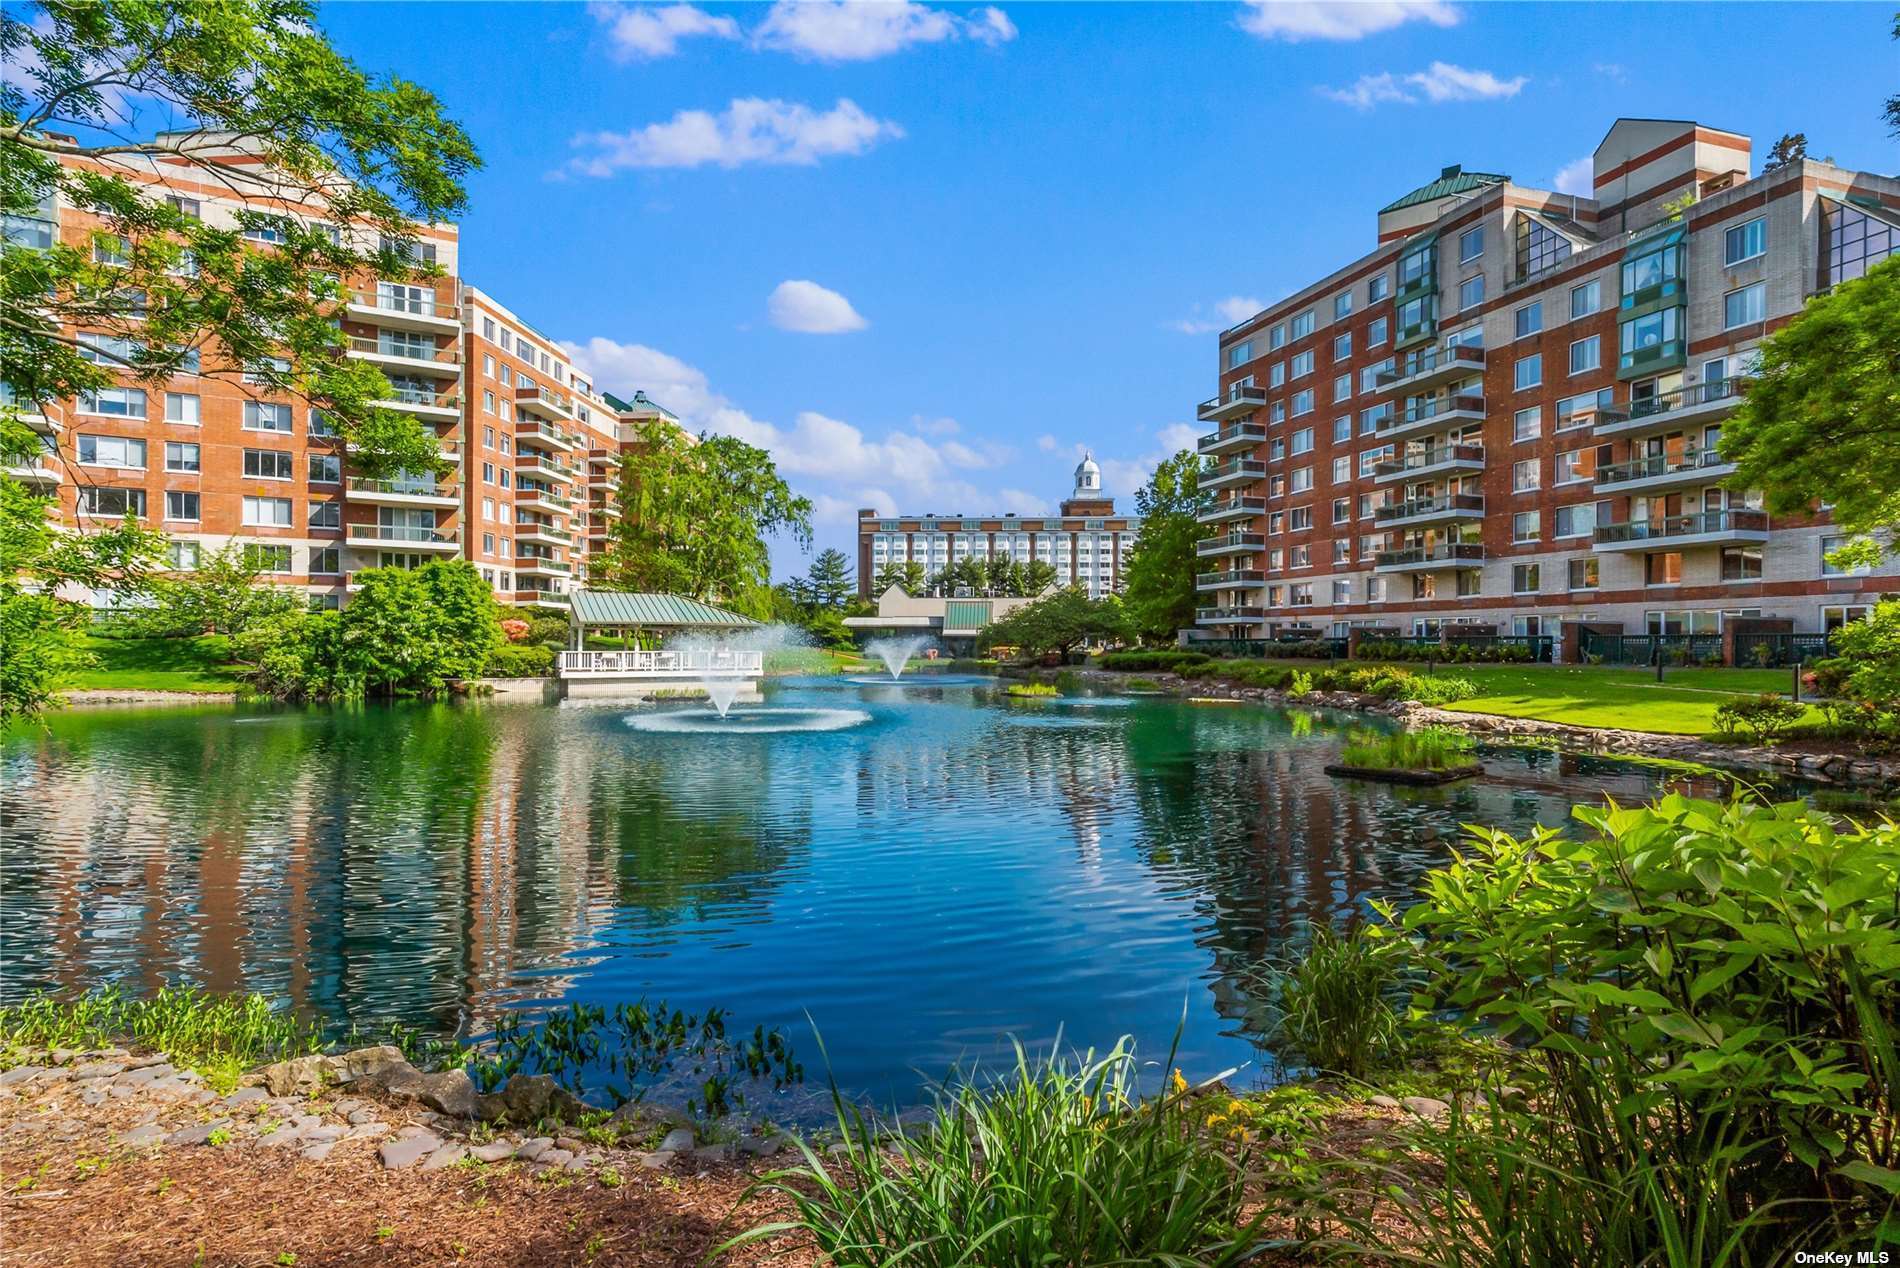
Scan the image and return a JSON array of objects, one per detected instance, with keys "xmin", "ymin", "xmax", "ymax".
[{"xmin": 722, "ymin": 1042, "xmax": 1265, "ymax": 1268}]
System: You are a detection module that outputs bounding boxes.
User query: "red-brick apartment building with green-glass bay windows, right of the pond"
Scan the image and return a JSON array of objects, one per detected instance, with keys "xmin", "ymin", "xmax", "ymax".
[{"xmin": 1197, "ymin": 120, "xmax": 1900, "ymax": 637}]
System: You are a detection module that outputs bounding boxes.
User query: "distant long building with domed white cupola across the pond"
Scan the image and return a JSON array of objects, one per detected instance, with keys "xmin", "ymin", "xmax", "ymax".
[{"xmin": 857, "ymin": 454, "xmax": 1142, "ymax": 599}]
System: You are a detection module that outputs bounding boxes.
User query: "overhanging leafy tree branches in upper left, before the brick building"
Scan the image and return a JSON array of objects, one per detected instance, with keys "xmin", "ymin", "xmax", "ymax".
[{"xmin": 0, "ymin": 0, "xmax": 477, "ymax": 719}]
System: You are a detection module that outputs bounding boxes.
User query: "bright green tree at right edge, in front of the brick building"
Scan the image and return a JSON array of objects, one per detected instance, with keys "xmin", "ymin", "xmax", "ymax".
[{"xmin": 1721, "ymin": 257, "xmax": 1900, "ymax": 563}]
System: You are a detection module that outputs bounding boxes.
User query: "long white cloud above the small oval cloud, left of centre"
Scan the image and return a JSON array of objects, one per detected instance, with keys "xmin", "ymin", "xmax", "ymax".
[{"xmin": 568, "ymin": 97, "xmax": 904, "ymax": 177}]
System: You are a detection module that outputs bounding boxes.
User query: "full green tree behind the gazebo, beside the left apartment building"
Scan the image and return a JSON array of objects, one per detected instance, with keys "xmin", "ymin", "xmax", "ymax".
[{"xmin": 599, "ymin": 418, "xmax": 811, "ymax": 616}]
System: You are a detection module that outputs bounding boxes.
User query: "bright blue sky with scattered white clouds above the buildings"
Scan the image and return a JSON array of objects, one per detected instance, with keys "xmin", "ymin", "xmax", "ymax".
[{"xmin": 321, "ymin": 0, "xmax": 1900, "ymax": 572}]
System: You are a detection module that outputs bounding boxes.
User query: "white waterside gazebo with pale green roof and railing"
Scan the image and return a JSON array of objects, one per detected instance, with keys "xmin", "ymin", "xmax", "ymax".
[{"xmin": 561, "ymin": 589, "xmax": 766, "ymax": 688}]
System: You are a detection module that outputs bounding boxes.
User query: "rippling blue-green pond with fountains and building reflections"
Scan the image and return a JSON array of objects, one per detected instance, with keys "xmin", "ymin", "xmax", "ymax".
[{"xmin": 0, "ymin": 679, "xmax": 1748, "ymax": 1105}]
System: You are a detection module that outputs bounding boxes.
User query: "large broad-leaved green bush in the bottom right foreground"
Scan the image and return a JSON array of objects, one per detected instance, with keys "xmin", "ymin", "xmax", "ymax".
[{"xmin": 1383, "ymin": 797, "xmax": 1900, "ymax": 1266}]
